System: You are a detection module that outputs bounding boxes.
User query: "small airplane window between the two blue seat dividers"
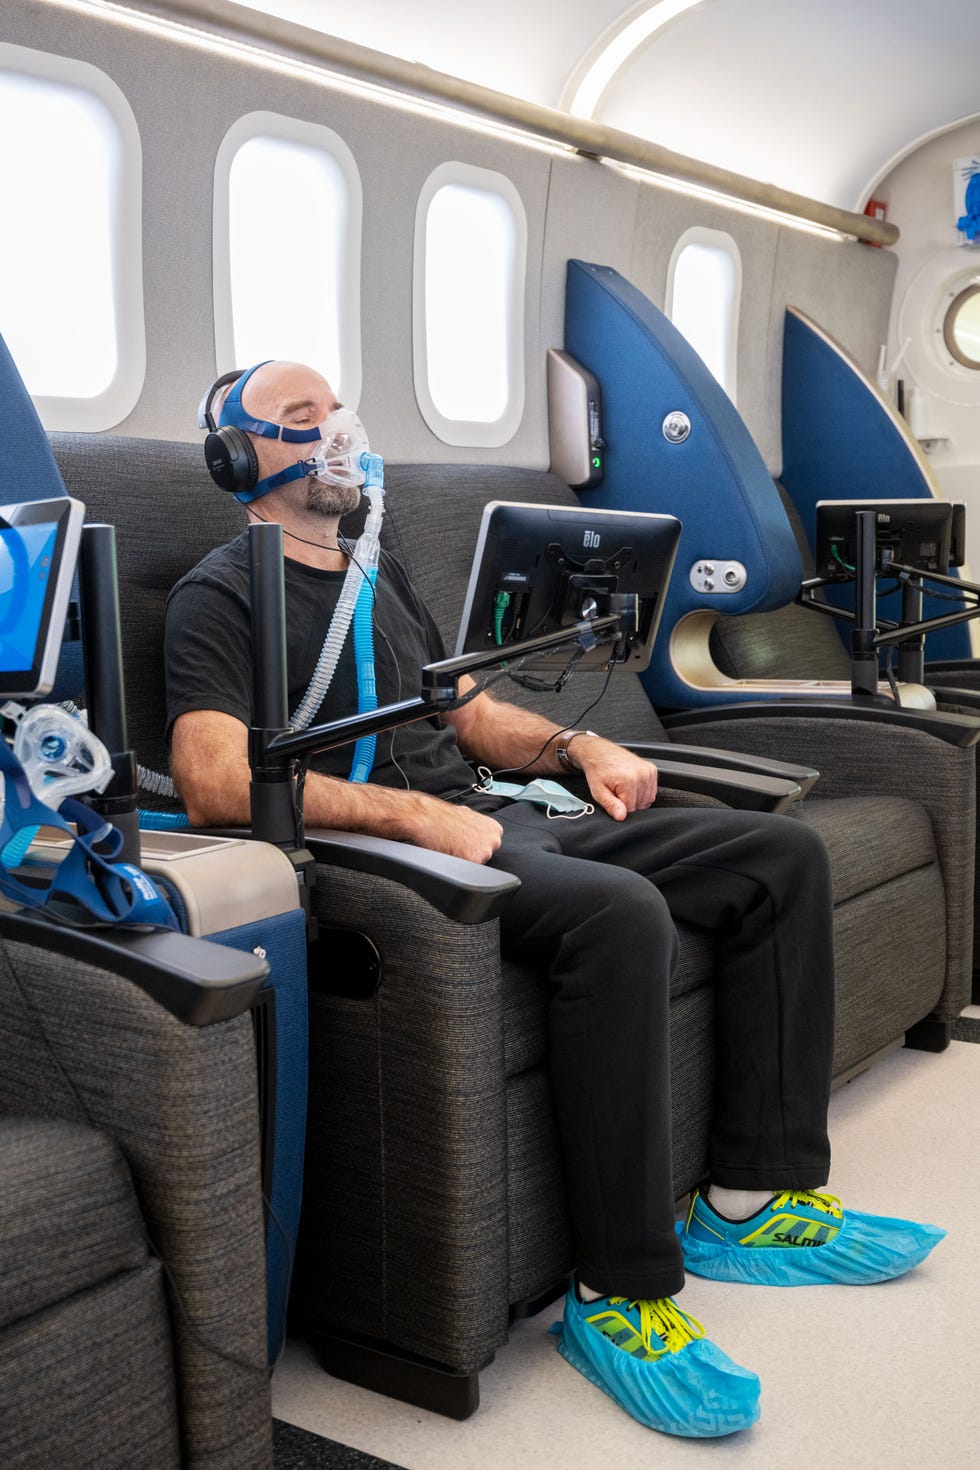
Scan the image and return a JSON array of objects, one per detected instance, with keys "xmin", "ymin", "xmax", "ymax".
[{"xmin": 667, "ymin": 226, "xmax": 742, "ymax": 403}]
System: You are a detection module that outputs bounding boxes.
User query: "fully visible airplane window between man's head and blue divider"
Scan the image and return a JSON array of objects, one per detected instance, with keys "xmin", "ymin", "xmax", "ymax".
[{"xmin": 413, "ymin": 163, "xmax": 527, "ymax": 445}]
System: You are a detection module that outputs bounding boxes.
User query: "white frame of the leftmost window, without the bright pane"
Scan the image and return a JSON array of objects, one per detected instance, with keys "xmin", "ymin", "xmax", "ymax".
[{"xmin": 0, "ymin": 41, "xmax": 147, "ymax": 432}]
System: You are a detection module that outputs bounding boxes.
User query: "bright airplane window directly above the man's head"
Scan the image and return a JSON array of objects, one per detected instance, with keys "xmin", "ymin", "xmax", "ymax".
[{"xmin": 215, "ymin": 113, "xmax": 361, "ymax": 407}]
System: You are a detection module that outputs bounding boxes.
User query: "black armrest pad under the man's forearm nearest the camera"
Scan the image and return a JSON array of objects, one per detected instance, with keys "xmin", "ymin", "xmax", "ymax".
[{"xmin": 306, "ymin": 828, "xmax": 520, "ymax": 923}]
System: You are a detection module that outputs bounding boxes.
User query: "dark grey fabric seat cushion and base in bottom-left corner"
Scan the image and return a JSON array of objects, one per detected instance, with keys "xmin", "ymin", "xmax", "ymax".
[{"xmin": 0, "ymin": 1117, "xmax": 181, "ymax": 1470}]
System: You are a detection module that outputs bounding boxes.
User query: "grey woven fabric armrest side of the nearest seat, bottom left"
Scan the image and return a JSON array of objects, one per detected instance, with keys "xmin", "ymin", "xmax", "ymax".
[{"xmin": 0, "ymin": 936, "xmax": 272, "ymax": 1470}]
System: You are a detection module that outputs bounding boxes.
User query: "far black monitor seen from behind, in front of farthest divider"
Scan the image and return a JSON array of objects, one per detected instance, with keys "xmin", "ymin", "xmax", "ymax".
[{"xmin": 815, "ymin": 500, "xmax": 964, "ymax": 581}]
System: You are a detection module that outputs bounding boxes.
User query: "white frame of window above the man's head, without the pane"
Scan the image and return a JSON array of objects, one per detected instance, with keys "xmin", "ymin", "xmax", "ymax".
[{"xmin": 212, "ymin": 112, "xmax": 363, "ymax": 409}]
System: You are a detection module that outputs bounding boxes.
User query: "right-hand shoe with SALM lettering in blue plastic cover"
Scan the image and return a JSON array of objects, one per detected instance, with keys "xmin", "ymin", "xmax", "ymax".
[{"xmin": 677, "ymin": 1189, "xmax": 946, "ymax": 1286}]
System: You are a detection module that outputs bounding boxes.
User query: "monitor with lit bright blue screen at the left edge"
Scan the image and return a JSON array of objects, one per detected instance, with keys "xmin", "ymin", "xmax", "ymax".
[{"xmin": 0, "ymin": 495, "xmax": 85, "ymax": 700}]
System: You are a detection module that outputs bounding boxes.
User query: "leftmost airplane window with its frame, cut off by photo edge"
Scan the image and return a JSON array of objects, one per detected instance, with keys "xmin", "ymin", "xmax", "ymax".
[{"xmin": 0, "ymin": 44, "xmax": 145, "ymax": 431}]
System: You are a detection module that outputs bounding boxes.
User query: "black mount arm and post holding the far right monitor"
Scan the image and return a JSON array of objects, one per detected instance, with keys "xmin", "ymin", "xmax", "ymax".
[{"xmin": 796, "ymin": 510, "xmax": 980, "ymax": 697}]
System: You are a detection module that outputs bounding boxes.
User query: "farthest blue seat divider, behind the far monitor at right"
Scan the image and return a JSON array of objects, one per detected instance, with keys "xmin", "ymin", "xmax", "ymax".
[{"xmin": 780, "ymin": 306, "xmax": 971, "ymax": 659}]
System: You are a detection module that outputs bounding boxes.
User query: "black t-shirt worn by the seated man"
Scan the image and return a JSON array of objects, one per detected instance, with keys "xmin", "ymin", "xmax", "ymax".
[{"xmin": 165, "ymin": 532, "xmax": 492, "ymax": 807}]
